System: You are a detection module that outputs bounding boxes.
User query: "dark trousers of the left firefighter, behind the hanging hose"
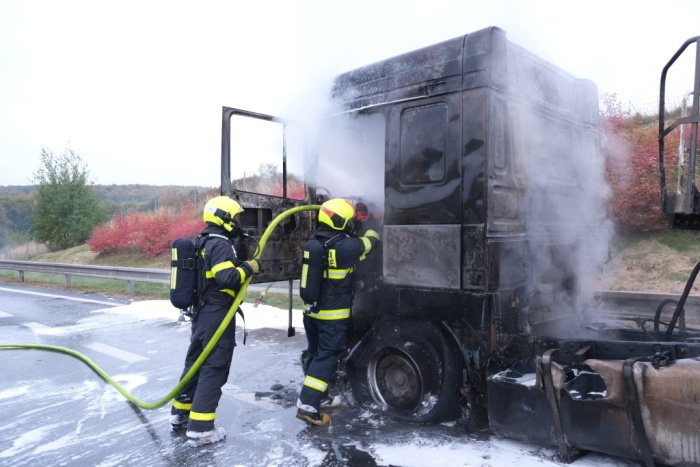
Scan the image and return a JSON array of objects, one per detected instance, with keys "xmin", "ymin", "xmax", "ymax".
[{"xmin": 171, "ymin": 305, "xmax": 236, "ymax": 431}]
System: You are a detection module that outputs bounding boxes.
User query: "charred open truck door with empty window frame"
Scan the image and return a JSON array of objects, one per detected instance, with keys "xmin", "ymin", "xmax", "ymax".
[{"xmin": 221, "ymin": 107, "xmax": 315, "ymax": 284}]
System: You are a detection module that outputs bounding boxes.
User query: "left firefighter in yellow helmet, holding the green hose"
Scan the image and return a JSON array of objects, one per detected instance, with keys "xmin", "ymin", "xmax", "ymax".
[{"xmin": 170, "ymin": 196, "xmax": 260, "ymax": 445}]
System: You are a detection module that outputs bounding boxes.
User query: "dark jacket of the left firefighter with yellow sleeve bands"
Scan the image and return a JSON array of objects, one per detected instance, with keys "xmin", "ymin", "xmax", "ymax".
[{"xmin": 199, "ymin": 224, "xmax": 253, "ymax": 308}]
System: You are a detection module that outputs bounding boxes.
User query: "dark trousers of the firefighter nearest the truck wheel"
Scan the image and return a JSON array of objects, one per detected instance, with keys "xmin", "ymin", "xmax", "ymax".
[{"xmin": 299, "ymin": 315, "xmax": 349, "ymax": 410}]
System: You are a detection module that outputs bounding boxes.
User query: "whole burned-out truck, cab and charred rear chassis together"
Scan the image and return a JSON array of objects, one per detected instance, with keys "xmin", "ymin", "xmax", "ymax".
[{"xmin": 222, "ymin": 27, "xmax": 700, "ymax": 465}]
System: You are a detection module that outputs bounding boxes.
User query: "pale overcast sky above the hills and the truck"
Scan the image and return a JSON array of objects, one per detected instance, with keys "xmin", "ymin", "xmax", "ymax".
[{"xmin": 0, "ymin": 0, "xmax": 700, "ymax": 186}]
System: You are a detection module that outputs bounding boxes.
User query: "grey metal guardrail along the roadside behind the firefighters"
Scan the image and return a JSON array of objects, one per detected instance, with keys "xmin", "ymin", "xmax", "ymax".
[{"xmin": 0, "ymin": 260, "xmax": 298, "ymax": 295}]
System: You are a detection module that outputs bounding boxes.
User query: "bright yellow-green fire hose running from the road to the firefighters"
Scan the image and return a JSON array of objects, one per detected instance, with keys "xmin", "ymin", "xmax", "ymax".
[{"xmin": 0, "ymin": 205, "xmax": 320, "ymax": 410}]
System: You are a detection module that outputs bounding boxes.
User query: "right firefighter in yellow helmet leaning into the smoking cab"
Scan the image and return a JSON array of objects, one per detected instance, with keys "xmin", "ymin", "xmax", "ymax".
[{"xmin": 296, "ymin": 198, "xmax": 380, "ymax": 426}]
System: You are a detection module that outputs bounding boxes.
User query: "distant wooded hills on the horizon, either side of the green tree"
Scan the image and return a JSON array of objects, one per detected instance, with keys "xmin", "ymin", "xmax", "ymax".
[{"xmin": 0, "ymin": 185, "xmax": 219, "ymax": 247}]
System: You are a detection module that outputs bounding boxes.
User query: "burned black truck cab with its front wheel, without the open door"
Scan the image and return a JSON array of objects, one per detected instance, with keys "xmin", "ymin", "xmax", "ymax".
[{"xmin": 335, "ymin": 24, "xmax": 609, "ymax": 424}]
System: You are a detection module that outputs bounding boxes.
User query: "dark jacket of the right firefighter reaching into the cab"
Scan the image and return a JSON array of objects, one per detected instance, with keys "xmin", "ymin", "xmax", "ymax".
[{"xmin": 299, "ymin": 225, "xmax": 379, "ymax": 320}]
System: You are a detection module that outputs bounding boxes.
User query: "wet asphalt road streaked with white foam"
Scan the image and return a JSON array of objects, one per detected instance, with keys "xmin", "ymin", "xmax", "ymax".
[{"xmin": 0, "ymin": 284, "xmax": 635, "ymax": 467}]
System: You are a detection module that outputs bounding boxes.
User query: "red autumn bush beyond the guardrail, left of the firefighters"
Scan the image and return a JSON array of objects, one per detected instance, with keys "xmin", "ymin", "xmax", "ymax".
[{"xmin": 88, "ymin": 203, "xmax": 204, "ymax": 258}]
